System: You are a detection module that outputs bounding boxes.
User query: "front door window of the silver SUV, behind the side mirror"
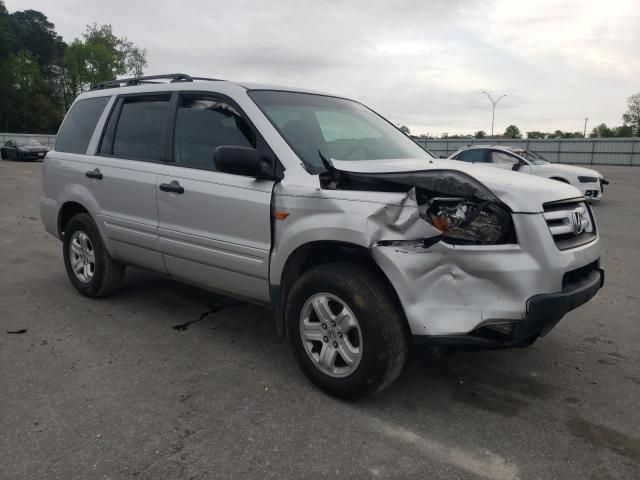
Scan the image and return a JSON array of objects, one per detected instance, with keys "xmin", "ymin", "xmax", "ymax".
[{"xmin": 173, "ymin": 96, "xmax": 256, "ymax": 170}]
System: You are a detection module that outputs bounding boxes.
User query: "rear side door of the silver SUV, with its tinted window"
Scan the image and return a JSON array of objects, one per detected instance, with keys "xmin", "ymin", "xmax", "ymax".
[{"xmin": 87, "ymin": 93, "xmax": 171, "ymax": 273}]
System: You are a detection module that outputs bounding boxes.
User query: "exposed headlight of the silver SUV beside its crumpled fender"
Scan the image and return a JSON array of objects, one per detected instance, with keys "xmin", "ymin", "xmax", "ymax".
[{"xmin": 423, "ymin": 197, "xmax": 515, "ymax": 245}]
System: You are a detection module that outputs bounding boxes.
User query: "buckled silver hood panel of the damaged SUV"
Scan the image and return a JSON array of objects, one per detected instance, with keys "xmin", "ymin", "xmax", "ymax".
[{"xmin": 331, "ymin": 159, "xmax": 582, "ymax": 213}]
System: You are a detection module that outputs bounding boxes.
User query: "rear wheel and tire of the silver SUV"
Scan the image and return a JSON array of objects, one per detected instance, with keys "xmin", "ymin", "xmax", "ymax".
[{"xmin": 62, "ymin": 213, "xmax": 125, "ymax": 298}]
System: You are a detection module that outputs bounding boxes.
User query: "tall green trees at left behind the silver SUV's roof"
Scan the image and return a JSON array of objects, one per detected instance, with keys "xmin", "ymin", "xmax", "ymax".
[{"xmin": 0, "ymin": 0, "xmax": 147, "ymax": 133}]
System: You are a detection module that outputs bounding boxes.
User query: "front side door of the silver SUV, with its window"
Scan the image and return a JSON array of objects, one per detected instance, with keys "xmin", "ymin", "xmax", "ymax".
[{"xmin": 157, "ymin": 93, "xmax": 274, "ymax": 301}]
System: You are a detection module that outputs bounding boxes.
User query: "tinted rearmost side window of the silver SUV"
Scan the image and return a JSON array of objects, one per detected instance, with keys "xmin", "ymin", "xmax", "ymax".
[{"xmin": 54, "ymin": 97, "xmax": 109, "ymax": 153}]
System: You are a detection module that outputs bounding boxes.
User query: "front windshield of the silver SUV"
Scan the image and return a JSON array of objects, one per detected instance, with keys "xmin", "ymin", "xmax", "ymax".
[{"xmin": 249, "ymin": 90, "xmax": 433, "ymax": 173}]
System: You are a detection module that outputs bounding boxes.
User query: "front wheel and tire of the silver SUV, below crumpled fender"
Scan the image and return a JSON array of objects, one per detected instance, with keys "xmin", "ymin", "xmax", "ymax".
[{"xmin": 285, "ymin": 262, "xmax": 408, "ymax": 400}]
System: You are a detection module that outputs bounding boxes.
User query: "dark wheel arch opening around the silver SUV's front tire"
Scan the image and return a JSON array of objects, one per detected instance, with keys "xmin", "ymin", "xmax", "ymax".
[{"xmin": 270, "ymin": 240, "xmax": 410, "ymax": 337}]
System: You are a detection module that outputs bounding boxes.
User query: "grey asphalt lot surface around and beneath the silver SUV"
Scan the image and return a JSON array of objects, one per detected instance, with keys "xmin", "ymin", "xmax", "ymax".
[{"xmin": 0, "ymin": 162, "xmax": 640, "ymax": 480}]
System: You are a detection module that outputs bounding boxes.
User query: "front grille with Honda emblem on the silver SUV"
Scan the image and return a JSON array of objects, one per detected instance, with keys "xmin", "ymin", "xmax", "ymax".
[{"xmin": 543, "ymin": 202, "xmax": 596, "ymax": 250}]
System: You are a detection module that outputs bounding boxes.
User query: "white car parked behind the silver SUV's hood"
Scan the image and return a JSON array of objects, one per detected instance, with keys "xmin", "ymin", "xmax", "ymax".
[{"xmin": 449, "ymin": 145, "xmax": 609, "ymax": 200}]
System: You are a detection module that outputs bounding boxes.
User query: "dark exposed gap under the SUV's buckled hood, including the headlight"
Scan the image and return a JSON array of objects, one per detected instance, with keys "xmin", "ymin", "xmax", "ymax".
[{"xmin": 321, "ymin": 168, "xmax": 517, "ymax": 245}]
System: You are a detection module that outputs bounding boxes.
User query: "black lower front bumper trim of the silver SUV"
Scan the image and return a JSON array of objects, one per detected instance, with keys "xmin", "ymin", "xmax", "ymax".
[{"xmin": 413, "ymin": 266, "xmax": 604, "ymax": 349}]
